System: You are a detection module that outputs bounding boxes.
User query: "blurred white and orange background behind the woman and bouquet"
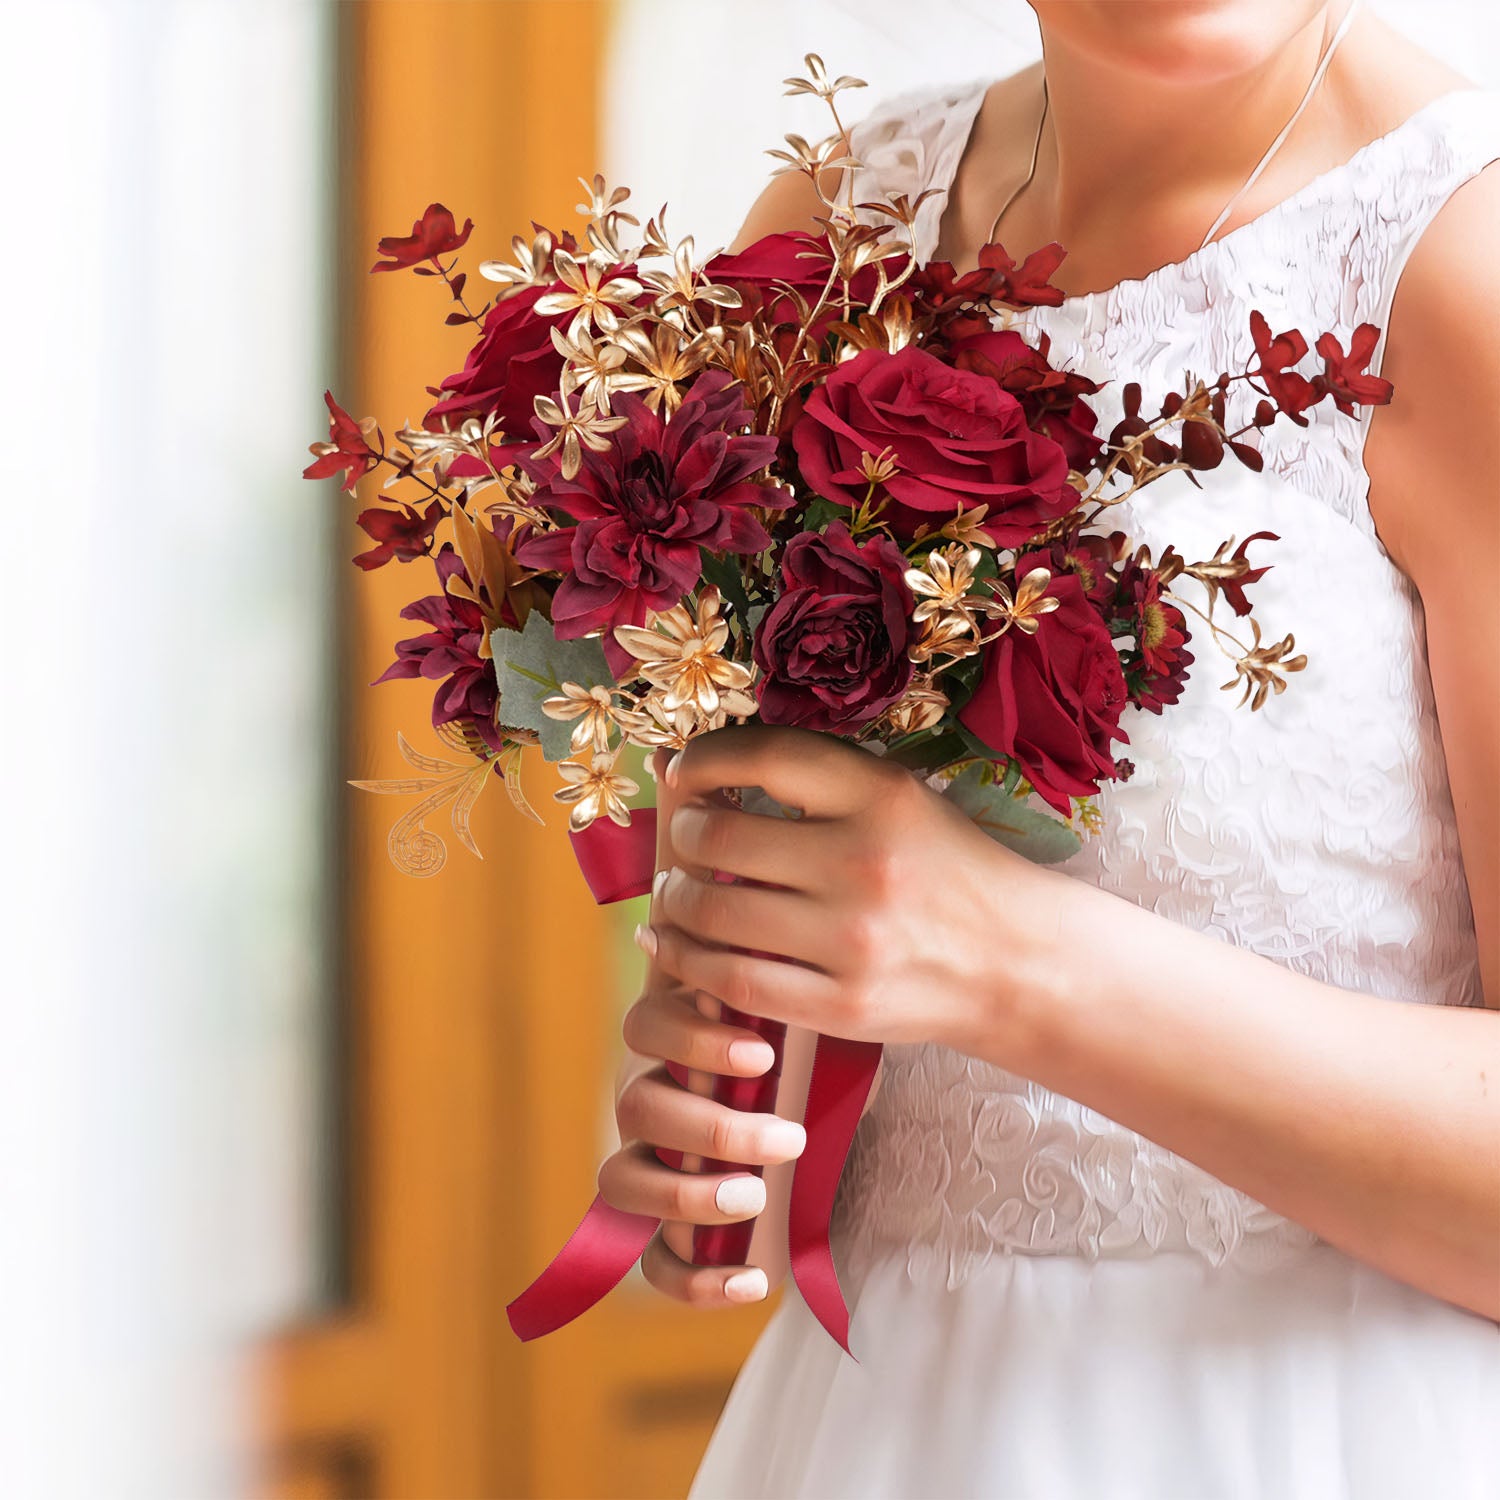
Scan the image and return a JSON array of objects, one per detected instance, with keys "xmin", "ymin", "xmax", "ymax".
[{"xmin": 0, "ymin": 0, "xmax": 1500, "ymax": 1500}]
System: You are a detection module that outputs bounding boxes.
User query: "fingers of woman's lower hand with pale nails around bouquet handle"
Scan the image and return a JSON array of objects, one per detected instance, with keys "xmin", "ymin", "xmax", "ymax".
[{"xmin": 599, "ymin": 974, "xmax": 807, "ymax": 1307}]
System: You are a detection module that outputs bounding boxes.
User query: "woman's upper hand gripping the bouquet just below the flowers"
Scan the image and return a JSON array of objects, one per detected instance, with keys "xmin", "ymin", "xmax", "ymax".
[{"xmin": 641, "ymin": 725, "xmax": 1097, "ymax": 1065}]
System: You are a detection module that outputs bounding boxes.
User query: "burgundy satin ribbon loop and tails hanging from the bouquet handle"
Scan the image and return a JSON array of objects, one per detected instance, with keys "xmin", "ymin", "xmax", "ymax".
[{"xmin": 506, "ymin": 809, "xmax": 881, "ymax": 1362}]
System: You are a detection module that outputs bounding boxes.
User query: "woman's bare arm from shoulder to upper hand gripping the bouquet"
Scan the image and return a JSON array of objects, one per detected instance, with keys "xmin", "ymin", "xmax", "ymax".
[{"xmin": 648, "ymin": 171, "xmax": 1500, "ymax": 1320}]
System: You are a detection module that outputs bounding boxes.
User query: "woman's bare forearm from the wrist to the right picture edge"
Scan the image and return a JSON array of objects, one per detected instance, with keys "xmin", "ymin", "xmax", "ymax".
[{"xmin": 962, "ymin": 876, "xmax": 1500, "ymax": 1322}]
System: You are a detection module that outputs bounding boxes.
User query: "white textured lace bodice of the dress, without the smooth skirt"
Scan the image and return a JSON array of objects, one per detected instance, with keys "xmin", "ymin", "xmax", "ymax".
[{"xmin": 834, "ymin": 80, "xmax": 1500, "ymax": 1286}]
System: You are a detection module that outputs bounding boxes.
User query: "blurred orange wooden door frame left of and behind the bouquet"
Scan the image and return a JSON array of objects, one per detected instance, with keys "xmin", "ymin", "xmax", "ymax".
[{"xmin": 264, "ymin": 0, "xmax": 770, "ymax": 1500}]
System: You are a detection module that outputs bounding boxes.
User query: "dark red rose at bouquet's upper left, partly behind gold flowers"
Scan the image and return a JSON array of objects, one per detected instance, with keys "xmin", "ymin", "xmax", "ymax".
[{"xmin": 423, "ymin": 285, "xmax": 572, "ymax": 440}]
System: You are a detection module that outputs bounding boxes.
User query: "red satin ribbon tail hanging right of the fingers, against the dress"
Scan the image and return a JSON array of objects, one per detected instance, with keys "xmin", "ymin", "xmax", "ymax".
[{"xmin": 788, "ymin": 1037, "xmax": 884, "ymax": 1364}]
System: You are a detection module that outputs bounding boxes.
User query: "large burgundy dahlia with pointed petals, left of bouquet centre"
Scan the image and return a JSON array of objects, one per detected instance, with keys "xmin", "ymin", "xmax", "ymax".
[{"xmin": 516, "ymin": 371, "xmax": 792, "ymax": 671}]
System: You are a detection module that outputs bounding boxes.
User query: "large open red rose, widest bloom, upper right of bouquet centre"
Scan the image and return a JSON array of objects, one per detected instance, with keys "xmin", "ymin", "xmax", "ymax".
[{"xmin": 792, "ymin": 345, "xmax": 1079, "ymax": 548}]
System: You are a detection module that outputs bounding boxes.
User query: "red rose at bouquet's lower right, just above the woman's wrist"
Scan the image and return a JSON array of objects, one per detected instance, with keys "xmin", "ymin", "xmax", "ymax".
[{"xmin": 959, "ymin": 552, "xmax": 1130, "ymax": 813}]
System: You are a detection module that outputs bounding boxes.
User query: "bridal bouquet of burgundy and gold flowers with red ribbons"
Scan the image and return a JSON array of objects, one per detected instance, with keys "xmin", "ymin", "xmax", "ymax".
[{"xmin": 305, "ymin": 57, "xmax": 1391, "ymax": 1341}]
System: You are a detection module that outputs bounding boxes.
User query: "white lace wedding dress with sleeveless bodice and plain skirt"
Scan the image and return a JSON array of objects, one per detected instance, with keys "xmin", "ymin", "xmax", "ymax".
[{"xmin": 692, "ymin": 80, "xmax": 1500, "ymax": 1500}]
